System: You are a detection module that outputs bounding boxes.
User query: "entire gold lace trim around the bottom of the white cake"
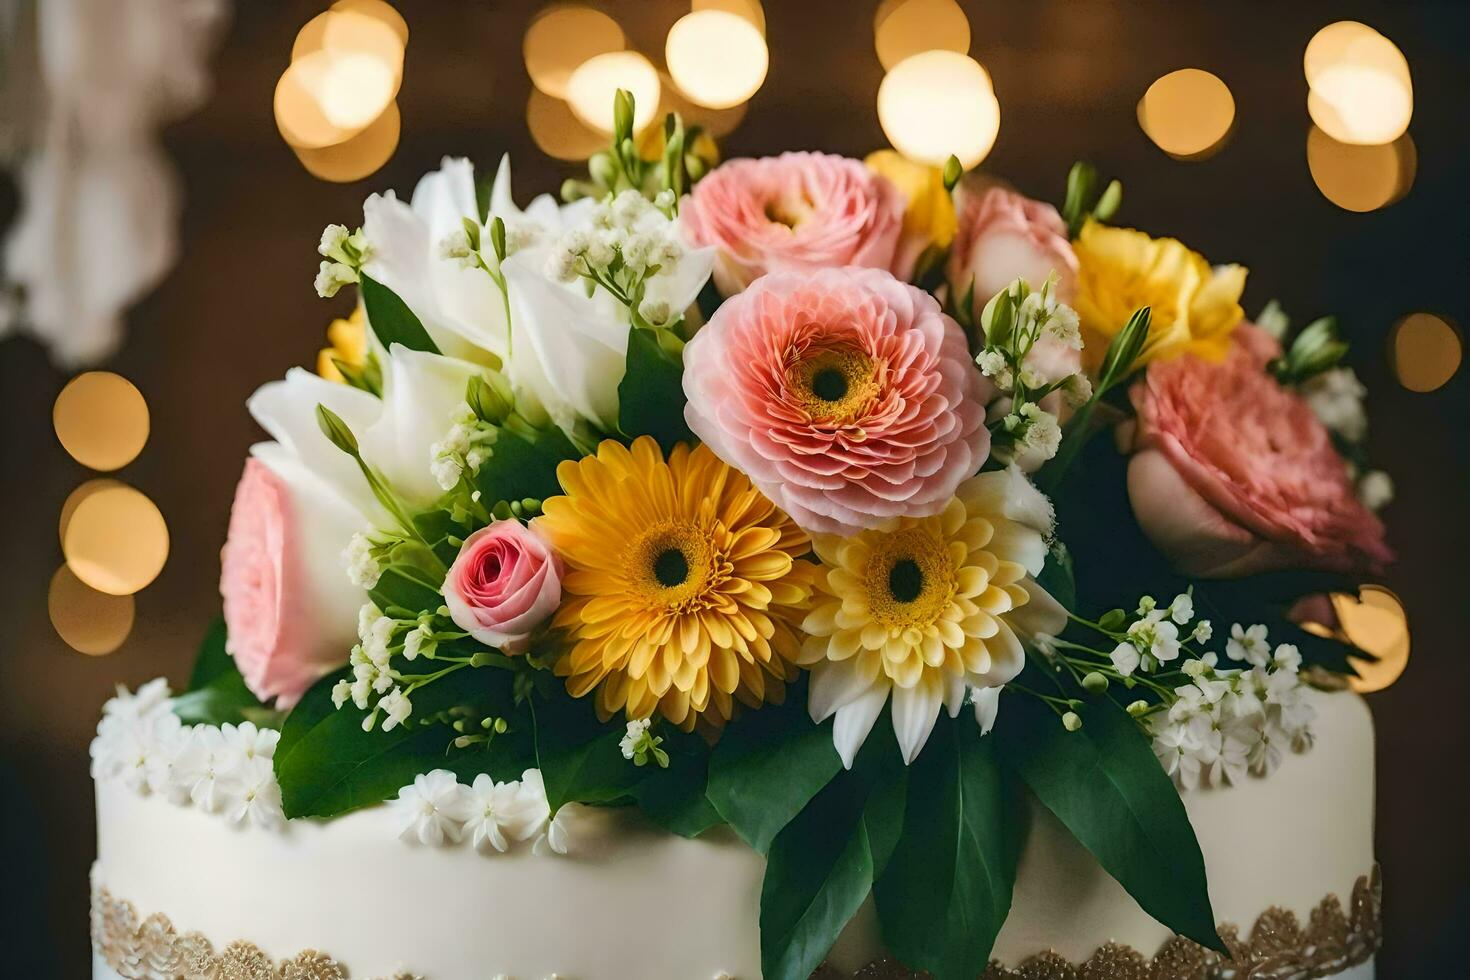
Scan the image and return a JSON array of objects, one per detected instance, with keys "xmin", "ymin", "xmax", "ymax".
[{"xmin": 91, "ymin": 865, "xmax": 1383, "ymax": 980}]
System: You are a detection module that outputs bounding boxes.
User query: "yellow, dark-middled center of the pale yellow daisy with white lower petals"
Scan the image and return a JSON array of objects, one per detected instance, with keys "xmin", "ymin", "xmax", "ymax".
[{"xmin": 863, "ymin": 525, "xmax": 956, "ymax": 632}]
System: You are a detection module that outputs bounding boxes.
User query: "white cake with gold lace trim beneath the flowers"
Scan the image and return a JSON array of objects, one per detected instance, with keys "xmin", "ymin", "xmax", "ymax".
[{"xmin": 93, "ymin": 692, "xmax": 1379, "ymax": 980}]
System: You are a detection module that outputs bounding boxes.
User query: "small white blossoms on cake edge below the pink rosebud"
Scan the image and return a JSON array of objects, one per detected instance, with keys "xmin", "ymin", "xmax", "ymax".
[{"xmin": 388, "ymin": 768, "xmax": 576, "ymax": 854}]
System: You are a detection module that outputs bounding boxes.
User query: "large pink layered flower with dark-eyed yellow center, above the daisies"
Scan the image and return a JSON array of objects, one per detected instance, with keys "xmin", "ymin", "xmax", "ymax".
[{"xmin": 684, "ymin": 267, "xmax": 994, "ymax": 533}]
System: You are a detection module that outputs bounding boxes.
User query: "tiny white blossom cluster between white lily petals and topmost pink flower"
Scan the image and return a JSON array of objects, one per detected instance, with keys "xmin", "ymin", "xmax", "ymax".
[{"xmin": 547, "ymin": 190, "xmax": 684, "ymax": 326}]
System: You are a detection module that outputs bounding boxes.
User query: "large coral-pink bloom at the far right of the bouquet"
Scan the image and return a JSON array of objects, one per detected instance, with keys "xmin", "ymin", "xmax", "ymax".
[{"xmin": 1127, "ymin": 335, "xmax": 1394, "ymax": 577}]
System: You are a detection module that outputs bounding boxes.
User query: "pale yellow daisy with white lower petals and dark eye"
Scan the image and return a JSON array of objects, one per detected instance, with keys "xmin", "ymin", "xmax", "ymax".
[{"xmin": 798, "ymin": 469, "xmax": 1066, "ymax": 767}]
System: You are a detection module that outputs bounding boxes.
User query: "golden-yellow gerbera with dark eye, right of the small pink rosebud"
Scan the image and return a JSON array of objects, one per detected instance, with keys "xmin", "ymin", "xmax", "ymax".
[{"xmin": 537, "ymin": 436, "xmax": 816, "ymax": 730}]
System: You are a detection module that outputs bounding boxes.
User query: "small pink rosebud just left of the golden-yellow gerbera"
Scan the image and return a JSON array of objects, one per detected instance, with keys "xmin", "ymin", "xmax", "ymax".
[{"xmin": 444, "ymin": 520, "xmax": 564, "ymax": 654}]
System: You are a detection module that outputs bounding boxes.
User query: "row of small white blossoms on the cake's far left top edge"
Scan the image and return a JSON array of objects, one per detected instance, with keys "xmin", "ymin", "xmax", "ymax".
[{"xmin": 91, "ymin": 677, "xmax": 284, "ymax": 827}]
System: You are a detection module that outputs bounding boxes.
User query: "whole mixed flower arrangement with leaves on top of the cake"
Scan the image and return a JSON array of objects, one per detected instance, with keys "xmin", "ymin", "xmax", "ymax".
[{"xmin": 108, "ymin": 93, "xmax": 1391, "ymax": 980}]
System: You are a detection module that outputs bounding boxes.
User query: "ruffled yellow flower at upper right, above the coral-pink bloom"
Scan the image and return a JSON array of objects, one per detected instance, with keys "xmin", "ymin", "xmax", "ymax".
[{"xmin": 1073, "ymin": 222, "xmax": 1245, "ymax": 370}]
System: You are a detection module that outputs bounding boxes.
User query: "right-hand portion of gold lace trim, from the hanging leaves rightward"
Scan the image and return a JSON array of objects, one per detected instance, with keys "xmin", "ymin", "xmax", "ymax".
[{"xmin": 813, "ymin": 865, "xmax": 1383, "ymax": 980}]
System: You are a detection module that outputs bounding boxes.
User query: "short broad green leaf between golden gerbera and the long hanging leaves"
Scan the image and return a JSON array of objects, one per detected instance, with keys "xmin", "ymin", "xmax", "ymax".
[{"xmin": 704, "ymin": 689, "xmax": 842, "ymax": 854}]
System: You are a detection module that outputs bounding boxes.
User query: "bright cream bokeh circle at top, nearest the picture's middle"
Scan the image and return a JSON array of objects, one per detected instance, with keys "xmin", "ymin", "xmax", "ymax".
[{"xmin": 664, "ymin": 10, "xmax": 769, "ymax": 109}]
